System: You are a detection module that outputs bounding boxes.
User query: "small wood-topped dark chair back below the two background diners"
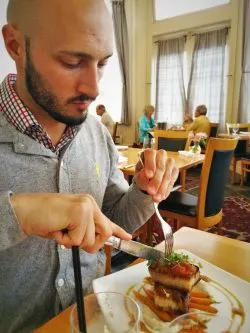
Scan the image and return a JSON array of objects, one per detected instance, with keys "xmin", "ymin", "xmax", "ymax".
[{"xmin": 154, "ymin": 130, "xmax": 191, "ymax": 151}]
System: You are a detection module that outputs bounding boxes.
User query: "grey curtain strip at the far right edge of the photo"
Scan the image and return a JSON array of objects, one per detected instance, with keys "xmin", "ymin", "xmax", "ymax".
[{"xmin": 238, "ymin": 0, "xmax": 250, "ymax": 123}]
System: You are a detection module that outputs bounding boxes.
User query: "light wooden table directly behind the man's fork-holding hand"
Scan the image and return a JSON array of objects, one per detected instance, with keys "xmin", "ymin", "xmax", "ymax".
[{"xmin": 118, "ymin": 147, "xmax": 205, "ymax": 191}]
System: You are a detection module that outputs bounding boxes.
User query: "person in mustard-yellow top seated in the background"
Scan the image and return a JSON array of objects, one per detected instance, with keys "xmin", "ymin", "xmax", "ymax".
[{"xmin": 184, "ymin": 104, "xmax": 210, "ymax": 137}]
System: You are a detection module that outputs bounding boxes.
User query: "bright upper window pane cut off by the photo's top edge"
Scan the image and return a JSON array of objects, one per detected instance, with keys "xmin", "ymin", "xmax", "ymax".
[{"xmin": 154, "ymin": 0, "xmax": 230, "ymax": 21}]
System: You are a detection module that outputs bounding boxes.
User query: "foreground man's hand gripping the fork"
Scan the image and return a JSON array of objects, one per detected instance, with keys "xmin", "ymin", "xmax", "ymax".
[{"xmin": 135, "ymin": 149, "xmax": 179, "ymax": 202}]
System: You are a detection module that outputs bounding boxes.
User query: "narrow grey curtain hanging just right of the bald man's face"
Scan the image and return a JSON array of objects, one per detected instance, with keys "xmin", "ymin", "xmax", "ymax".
[{"xmin": 112, "ymin": 0, "xmax": 131, "ymax": 125}]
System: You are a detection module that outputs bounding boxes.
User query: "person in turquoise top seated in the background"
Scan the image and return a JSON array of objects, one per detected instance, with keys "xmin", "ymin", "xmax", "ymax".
[{"xmin": 139, "ymin": 105, "xmax": 157, "ymax": 144}]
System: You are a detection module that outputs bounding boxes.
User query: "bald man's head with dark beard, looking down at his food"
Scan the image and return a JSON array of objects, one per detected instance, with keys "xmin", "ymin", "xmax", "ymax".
[{"xmin": 2, "ymin": 0, "xmax": 113, "ymax": 124}]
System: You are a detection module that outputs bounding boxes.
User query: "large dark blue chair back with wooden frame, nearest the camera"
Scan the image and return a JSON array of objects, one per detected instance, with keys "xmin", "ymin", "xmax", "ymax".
[{"xmin": 197, "ymin": 138, "xmax": 238, "ymax": 229}]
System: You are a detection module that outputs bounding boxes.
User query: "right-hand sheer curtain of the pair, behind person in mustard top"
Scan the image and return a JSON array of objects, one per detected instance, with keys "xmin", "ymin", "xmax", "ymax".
[{"xmin": 187, "ymin": 29, "xmax": 227, "ymax": 128}]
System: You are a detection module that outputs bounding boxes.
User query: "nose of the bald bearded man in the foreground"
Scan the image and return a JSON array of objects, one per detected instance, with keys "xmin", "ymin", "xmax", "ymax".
[{"xmin": 77, "ymin": 66, "xmax": 100, "ymax": 99}]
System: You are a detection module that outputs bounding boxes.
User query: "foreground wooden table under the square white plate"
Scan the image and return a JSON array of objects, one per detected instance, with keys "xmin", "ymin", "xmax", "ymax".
[{"xmin": 34, "ymin": 227, "xmax": 250, "ymax": 333}]
